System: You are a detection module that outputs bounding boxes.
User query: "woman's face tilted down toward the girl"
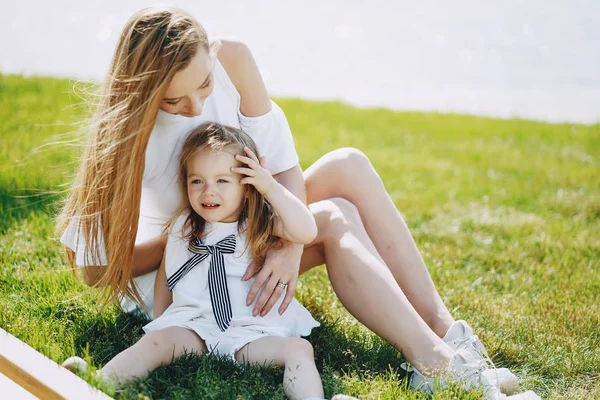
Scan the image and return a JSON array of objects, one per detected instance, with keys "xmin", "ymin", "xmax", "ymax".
[{"xmin": 160, "ymin": 49, "xmax": 215, "ymax": 117}]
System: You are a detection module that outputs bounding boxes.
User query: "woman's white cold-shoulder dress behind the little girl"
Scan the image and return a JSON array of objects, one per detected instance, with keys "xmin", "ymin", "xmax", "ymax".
[{"xmin": 61, "ymin": 59, "xmax": 299, "ymax": 318}]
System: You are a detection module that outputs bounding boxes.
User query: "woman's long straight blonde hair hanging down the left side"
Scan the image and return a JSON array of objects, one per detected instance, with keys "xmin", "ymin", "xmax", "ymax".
[{"xmin": 56, "ymin": 7, "xmax": 216, "ymax": 306}]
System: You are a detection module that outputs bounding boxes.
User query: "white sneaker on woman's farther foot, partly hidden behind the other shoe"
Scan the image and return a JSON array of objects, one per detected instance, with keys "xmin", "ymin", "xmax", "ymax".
[{"xmin": 443, "ymin": 320, "xmax": 519, "ymax": 394}]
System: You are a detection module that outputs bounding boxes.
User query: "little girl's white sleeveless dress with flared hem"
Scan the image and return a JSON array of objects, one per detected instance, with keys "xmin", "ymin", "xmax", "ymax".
[{"xmin": 144, "ymin": 215, "xmax": 319, "ymax": 360}]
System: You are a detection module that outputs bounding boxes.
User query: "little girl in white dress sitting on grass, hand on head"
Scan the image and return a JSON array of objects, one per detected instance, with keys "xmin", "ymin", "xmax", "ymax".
[{"xmin": 63, "ymin": 123, "xmax": 356, "ymax": 399}]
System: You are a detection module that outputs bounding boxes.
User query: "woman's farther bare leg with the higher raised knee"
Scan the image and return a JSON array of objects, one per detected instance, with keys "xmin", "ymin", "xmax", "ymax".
[{"xmin": 304, "ymin": 148, "xmax": 454, "ymax": 337}]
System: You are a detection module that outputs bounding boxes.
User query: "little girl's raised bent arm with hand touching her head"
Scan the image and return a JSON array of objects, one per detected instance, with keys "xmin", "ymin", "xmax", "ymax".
[{"xmin": 232, "ymin": 148, "xmax": 317, "ymax": 244}]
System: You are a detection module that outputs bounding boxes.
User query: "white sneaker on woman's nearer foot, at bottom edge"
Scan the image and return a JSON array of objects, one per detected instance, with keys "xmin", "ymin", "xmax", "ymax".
[{"xmin": 405, "ymin": 350, "xmax": 540, "ymax": 400}]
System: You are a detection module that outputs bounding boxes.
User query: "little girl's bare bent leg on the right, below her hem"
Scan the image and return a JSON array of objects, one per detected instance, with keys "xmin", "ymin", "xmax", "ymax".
[{"xmin": 235, "ymin": 336, "xmax": 324, "ymax": 399}]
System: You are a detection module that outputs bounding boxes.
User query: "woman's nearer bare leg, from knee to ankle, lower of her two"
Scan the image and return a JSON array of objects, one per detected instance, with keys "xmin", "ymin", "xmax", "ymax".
[{"xmin": 300, "ymin": 198, "xmax": 453, "ymax": 375}]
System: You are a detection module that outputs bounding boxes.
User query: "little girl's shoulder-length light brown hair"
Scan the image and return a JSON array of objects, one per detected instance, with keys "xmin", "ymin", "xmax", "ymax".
[{"xmin": 172, "ymin": 122, "xmax": 278, "ymax": 265}]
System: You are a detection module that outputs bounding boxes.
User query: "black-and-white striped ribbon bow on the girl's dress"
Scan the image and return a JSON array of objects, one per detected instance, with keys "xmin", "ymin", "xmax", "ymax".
[{"xmin": 167, "ymin": 235, "xmax": 235, "ymax": 331}]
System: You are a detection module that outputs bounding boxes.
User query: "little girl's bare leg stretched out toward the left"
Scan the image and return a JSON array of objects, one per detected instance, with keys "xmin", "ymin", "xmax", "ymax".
[{"xmin": 101, "ymin": 327, "xmax": 206, "ymax": 383}]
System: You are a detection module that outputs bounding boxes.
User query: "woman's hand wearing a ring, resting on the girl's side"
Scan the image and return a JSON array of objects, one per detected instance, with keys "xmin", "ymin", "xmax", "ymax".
[{"xmin": 242, "ymin": 242, "xmax": 304, "ymax": 317}]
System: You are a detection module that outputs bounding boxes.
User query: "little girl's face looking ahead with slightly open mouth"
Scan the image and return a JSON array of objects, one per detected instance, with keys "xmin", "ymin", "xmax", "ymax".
[{"xmin": 186, "ymin": 148, "xmax": 245, "ymax": 222}]
